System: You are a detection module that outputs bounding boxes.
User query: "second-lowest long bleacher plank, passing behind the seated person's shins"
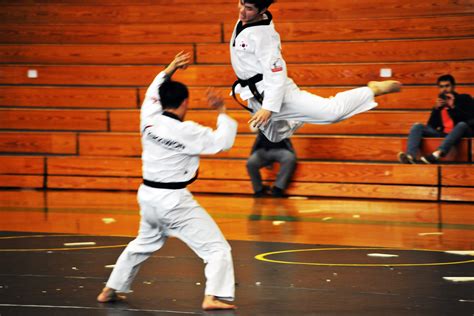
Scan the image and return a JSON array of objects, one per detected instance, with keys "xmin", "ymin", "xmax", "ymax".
[{"xmin": 48, "ymin": 157, "xmax": 438, "ymax": 185}]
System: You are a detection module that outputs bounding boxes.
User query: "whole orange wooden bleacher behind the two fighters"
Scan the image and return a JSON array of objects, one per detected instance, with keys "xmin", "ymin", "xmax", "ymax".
[{"xmin": 0, "ymin": 0, "xmax": 474, "ymax": 201}]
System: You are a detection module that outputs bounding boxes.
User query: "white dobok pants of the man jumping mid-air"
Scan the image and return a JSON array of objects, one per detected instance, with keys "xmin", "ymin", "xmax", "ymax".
[{"xmin": 248, "ymin": 82, "xmax": 378, "ymax": 142}]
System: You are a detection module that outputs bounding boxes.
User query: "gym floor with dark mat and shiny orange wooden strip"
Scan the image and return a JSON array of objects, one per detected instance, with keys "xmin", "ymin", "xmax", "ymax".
[{"xmin": 0, "ymin": 190, "xmax": 474, "ymax": 316}]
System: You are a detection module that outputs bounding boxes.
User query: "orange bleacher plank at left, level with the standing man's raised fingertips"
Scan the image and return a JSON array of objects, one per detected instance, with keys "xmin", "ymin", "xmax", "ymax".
[{"xmin": 0, "ymin": 44, "xmax": 194, "ymax": 65}]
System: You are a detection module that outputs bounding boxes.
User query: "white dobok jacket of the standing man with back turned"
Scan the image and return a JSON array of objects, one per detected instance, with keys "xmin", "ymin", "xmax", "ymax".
[{"xmin": 140, "ymin": 72, "xmax": 237, "ymax": 183}]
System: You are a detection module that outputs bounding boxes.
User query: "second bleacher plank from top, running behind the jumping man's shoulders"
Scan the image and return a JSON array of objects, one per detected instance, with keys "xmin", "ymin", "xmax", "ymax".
[{"xmin": 224, "ymin": 15, "xmax": 474, "ymax": 42}]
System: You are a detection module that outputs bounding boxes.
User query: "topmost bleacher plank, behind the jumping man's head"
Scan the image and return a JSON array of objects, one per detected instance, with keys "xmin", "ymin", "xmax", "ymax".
[{"xmin": 0, "ymin": 0, "xmax": 474, "ymax": 24}]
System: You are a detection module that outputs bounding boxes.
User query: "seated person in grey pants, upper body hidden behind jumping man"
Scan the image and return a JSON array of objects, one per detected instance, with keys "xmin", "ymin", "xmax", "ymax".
[{"xmin": 247, "ymin": 132, "xmax": 296, "ymax": 197}]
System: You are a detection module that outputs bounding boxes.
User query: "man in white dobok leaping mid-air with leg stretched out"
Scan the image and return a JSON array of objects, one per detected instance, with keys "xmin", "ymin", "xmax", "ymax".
[{"xmin": 230, "ymin": 0, "xmax": 401, "ymax": 142}]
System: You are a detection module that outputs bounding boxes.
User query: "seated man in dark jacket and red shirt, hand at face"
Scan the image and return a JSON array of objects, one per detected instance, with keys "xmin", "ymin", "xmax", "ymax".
[{"xmin": 398, "ymin": 75, "xmax": 474, "ymax": 164}]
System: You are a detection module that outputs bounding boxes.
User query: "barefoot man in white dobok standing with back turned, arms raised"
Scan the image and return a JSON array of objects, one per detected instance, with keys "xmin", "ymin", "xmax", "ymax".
[{"xmin": 97, "ymin": 52, "xmax": 237, "ymax": 310}]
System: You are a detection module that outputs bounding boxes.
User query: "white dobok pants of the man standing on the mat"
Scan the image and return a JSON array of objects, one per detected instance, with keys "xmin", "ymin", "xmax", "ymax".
[{"xmin": 106, "ymin": 185, "xmax": 235, "ymax": 300}]
